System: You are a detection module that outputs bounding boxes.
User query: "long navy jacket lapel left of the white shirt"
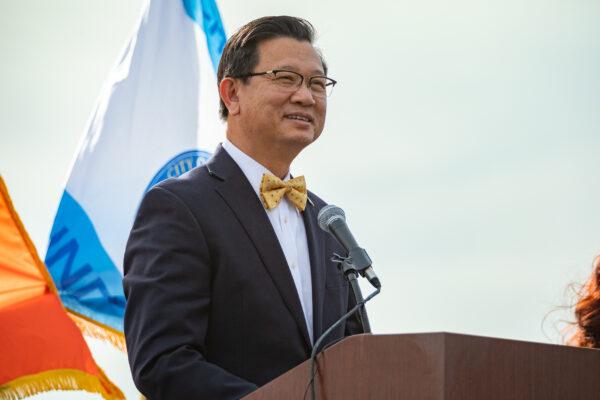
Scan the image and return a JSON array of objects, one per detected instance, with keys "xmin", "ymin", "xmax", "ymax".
[{"xmin": 206, "ymin": 146, "xmax": 310, "ymax": 348}]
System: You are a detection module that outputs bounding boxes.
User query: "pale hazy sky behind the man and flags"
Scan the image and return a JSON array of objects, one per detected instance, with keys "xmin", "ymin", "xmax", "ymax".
[{"xmin": 0, "ymin": 0, "xmax": 600, "ymax": 399}]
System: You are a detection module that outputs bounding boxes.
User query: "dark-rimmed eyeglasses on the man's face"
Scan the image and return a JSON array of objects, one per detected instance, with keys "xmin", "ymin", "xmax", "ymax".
[{"xmin": 232, "ymin": 69, "xmax": 337, "ymax": 98}]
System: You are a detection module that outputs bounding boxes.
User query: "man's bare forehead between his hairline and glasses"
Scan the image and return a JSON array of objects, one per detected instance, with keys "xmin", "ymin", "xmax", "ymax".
[{"xmin": 256, "ymin": 37, "xmax": 323, "ymax": 73}]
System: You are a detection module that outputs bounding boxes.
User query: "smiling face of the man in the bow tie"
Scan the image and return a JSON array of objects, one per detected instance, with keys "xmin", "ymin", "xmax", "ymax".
[{"xmin": 238, "ymin": 37, "xmax": 327, "ymax": 152}]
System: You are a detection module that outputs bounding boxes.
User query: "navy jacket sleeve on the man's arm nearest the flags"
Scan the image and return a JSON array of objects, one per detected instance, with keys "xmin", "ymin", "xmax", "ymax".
[{"xmin": 123, "ymin": 187, "xmax": 257, "ymax": 400}]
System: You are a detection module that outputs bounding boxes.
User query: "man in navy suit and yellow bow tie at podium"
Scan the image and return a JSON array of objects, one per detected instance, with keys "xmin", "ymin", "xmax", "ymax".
[{"xmin": 123, "ymin": 17, "xmax": 360, "ymax": 400}]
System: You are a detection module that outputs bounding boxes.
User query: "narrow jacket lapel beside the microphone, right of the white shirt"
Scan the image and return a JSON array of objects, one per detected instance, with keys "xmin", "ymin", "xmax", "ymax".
[{"xmin": 302, "ymin": 198, "xmax": 327, "ymax": 340}]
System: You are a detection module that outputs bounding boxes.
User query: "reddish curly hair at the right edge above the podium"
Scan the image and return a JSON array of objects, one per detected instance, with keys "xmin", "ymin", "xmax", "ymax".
[{"xmin": 569, "ymin": 255, "xmax": 600, "ymax": 348}]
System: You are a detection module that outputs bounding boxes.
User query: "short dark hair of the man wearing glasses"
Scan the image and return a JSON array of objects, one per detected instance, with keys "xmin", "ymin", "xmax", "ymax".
[{"xmin": 217, "ymin": 15, "xmax": 327, "ymax": 120}]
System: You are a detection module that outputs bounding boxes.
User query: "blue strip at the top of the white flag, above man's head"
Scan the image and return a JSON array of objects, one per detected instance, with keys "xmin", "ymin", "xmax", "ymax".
[{"xmin": 183, "ymin": 0, "xmax": 227, "ymax": 72}]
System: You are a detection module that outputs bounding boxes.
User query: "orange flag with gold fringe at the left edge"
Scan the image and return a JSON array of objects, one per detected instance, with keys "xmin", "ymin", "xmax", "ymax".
[{"xmin": 0, "ymin": 176, "xmax": 125, "ymax": 400}]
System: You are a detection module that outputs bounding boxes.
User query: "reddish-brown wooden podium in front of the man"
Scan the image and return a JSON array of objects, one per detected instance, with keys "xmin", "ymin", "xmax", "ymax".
[{"xmin": 244, "ymin": 333, "xmax": 600, "ymax": 400}]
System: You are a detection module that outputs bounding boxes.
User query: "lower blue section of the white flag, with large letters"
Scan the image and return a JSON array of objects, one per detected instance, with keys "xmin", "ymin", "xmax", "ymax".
[{"xmin": 45, "ymin": 190, "xmax": 125, "ymax": 332}]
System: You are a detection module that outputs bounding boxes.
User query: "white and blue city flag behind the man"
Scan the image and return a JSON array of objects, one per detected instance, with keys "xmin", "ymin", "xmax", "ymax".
[{"xmin": 46, "ymin": 0, "xmax": 226, "ymax": 332}]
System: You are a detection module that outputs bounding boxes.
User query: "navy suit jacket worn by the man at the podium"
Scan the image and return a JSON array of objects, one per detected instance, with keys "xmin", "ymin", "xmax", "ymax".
[{"xmin": 123, "ymin": 146, "xmax": 360, "ymax": 400}]
